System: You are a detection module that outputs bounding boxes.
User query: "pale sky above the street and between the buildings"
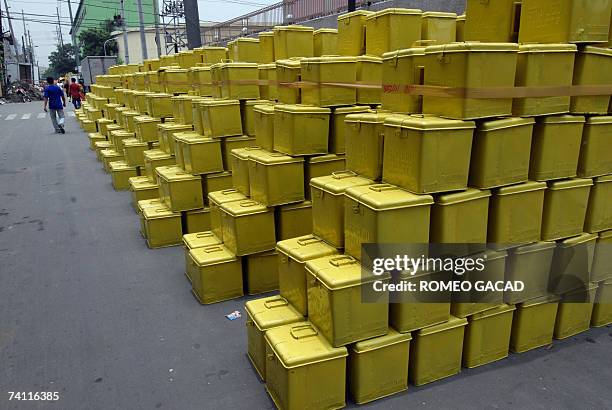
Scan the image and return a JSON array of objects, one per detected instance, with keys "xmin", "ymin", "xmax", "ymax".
[{"xmin": 0, "ymin": 0, "xmax": 281, "ymax": 67}]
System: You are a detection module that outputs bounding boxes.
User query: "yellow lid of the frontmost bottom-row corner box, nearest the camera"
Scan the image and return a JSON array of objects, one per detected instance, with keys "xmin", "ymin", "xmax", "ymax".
[{"xmin": 265, "ymin": 322, "xmax": 348, "ymax": 369}]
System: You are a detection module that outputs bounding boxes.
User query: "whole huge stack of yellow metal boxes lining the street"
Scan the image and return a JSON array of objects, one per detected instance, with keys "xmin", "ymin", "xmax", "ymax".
[{"xmin": 78, "ymin": 0, "xmax": 612, "ymax": 408}]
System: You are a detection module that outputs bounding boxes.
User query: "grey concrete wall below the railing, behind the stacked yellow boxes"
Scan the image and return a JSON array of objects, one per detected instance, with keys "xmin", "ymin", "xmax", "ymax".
[{"xmin": 300, "ymin": 0, "xmax": 466, "ymax": 29}]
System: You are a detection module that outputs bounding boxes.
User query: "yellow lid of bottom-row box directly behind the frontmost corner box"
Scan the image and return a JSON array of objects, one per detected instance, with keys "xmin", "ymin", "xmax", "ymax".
[{"xmin": 245, "ymin": 295, "xmax": 304, "ymax": 331}]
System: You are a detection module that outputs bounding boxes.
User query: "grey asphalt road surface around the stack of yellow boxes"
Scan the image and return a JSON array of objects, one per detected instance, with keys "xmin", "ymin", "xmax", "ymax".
[{"xmin": 0, "ymin": 103, "xmax": 612, "ymax": 410}]
